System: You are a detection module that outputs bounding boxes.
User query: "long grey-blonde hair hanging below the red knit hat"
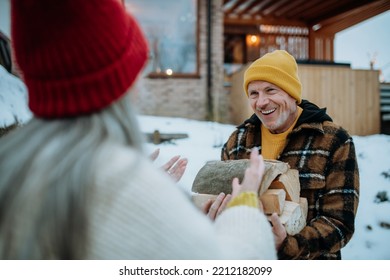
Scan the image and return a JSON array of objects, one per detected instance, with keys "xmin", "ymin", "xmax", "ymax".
[{"xmin": 0, "ymin": 95, "xmax": 142, "ymax": 259}]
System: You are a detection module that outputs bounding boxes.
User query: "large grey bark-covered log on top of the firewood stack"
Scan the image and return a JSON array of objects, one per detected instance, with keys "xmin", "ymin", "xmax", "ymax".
[{"xmin": 191, "ymin": 159, "xmax": 289, "ymax": 195}]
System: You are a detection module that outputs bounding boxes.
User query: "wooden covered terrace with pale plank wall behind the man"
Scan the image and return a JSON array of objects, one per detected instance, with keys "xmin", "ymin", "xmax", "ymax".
[{"xmin": 223, "ymin": 0, "xmax": 390, "ymax": 135}]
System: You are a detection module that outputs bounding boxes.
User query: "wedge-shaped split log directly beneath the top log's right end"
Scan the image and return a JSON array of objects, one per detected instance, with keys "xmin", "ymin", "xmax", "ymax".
[{"xmin": 269, "ymin": 169, "xmax": 301, "ymax": 203}]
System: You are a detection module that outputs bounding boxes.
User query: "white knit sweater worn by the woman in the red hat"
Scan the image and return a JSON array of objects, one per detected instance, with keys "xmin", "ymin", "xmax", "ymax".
[{"xmin": 87, "ymin": 148, "xmax": 276, "ymax": 259}]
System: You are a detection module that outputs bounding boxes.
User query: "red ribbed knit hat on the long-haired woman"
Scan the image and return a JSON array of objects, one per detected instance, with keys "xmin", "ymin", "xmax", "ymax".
[{"xmin": 11, "ymin": 0, "xmax": 148, "ymax": 118}]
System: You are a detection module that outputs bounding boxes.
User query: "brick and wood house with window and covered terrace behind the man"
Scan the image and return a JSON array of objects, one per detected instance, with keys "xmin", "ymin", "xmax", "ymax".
[{"xmin": 0, "ymin": 0, "xmax": 390, "ymax": 135}]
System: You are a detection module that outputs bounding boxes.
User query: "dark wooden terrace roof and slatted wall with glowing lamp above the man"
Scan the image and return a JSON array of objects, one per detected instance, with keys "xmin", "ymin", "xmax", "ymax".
[{"xmin": 223, "ymin": 0, "xmax": 390, "ymax": 63}]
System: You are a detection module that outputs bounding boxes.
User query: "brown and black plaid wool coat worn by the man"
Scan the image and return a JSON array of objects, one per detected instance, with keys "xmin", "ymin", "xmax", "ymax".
[{"xmin": 221, "ymin": 100, "xmax": 359, "ymax": 260}]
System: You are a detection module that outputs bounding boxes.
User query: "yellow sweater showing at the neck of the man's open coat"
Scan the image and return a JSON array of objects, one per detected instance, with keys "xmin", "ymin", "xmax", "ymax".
[{"xmin": 261, "ymin": 107, "xmax": 302, "ymax": 159}]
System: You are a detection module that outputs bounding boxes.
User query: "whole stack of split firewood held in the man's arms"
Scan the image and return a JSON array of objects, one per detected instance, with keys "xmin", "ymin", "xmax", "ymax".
[{"xmin": 192, "ymin": 159, "xmax": 308, "ymax": 235}]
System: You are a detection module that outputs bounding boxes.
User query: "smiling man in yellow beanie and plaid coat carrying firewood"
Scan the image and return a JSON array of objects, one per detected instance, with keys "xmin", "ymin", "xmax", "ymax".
[{"xmin": 221, "ymin": 50, "xmax": 359, "ymax": 260}]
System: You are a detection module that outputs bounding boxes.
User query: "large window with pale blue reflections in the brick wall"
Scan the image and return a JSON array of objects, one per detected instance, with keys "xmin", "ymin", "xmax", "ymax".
[{"xmin": 124, "ymin": 0, "xmax": 198, "ymax": 78}]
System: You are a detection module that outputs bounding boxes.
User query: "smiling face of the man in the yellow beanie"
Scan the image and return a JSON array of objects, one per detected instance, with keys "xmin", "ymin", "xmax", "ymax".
[{"xmin": 248, "ymin": 81, "xmax": 297, "ymax": 133}]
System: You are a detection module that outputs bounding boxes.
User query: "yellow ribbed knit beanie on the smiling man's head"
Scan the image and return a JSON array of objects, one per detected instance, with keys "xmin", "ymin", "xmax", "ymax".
[{"xmin": 244, "ymin": 50, "xmax": 302, "ymax": 104}]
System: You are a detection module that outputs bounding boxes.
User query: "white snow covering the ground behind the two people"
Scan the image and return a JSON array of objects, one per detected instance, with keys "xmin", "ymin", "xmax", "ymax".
[{"xmin": 0, "ymin": 66, "xmax": 390, "ymax": 260}]
